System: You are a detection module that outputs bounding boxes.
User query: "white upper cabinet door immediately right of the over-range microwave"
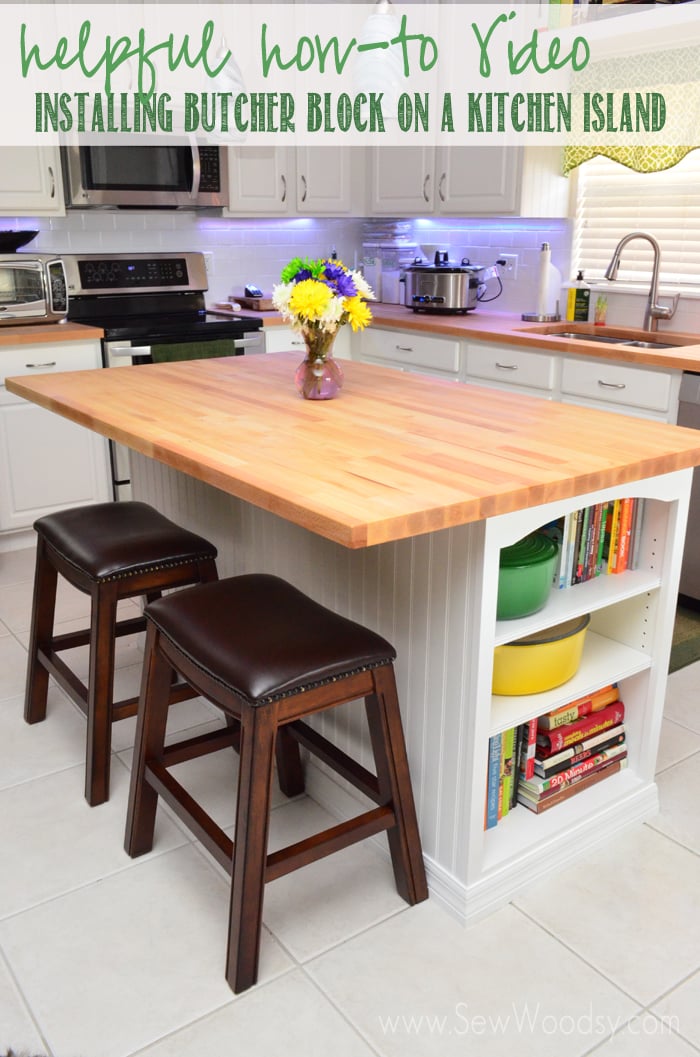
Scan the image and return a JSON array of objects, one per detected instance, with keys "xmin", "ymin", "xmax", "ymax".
[{"xmin": 225, "ymin": 146, "xmax": 295, "ymax": 216}]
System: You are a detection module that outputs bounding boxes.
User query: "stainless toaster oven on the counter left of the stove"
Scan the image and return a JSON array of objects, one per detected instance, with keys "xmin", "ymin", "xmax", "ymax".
[{"xmin": 0, "ymin": 254, "xmax": 68, "ymax": 327}]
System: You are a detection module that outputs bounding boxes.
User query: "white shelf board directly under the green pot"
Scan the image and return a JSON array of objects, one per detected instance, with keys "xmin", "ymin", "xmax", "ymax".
[{"xmin": 494, "ymin": 569, "xmax": 661, "ymax": 646}]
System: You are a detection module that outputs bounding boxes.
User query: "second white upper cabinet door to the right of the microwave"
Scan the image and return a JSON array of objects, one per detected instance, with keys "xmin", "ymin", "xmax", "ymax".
[{"xmin": 296, "ymin": 147, "xmax": 352, "ymax": 216}]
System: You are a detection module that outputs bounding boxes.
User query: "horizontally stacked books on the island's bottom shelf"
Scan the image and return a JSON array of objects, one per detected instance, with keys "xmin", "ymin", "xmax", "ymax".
[{"xmin": 517, "ymin": 684, "xmax": 627, "ymax": 814}]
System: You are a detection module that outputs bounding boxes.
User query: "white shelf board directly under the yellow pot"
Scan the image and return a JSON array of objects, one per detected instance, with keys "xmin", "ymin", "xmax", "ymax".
[{"xmin": 490, "ymin": 630, "xmax": 651, "ymax": 735}]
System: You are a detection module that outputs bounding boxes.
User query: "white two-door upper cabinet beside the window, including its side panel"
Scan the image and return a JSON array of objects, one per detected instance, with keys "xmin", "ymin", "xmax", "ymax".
[{"xmin": 368, "ymin": 146, "xmax": 569, "ymax": 217}]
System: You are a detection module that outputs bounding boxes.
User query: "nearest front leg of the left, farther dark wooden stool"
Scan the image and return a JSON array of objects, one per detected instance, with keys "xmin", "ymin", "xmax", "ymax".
[{"xmin": 85, "ymin": 583, "xmax": 117, "ymax": 806}]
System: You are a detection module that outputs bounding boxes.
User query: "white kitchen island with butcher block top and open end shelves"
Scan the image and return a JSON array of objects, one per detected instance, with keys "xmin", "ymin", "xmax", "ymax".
[{"xmin": 7, "ymin": 354, "xmax": 700, "ymax": 917}]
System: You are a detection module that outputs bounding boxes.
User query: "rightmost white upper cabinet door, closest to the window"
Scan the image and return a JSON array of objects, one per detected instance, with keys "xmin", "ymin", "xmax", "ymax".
[{"xmin": 436, "ymin": 147, "xmax": 522, "ymax": 216}]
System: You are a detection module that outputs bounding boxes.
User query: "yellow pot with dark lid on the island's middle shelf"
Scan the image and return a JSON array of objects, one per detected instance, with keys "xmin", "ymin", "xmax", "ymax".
[{"xmin": 493, "ymin": 613, "xmax": 591, "ymax": 697}]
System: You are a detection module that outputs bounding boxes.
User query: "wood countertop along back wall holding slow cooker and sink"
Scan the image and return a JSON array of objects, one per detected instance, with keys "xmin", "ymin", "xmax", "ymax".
[{"xmin": 237, "ymin": 302, "xmax": 700, "ymax": 372}]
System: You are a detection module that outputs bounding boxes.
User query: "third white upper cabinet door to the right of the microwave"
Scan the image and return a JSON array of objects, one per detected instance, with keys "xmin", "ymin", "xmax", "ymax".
[{"xmin": 368, "ymin": 147, "xmax": 435, "ymax": 216}]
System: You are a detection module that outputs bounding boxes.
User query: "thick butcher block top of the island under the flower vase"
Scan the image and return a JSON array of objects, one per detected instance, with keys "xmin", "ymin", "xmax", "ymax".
[{"xmin": 6, "ymin": 353, "xmax": 700, "ymax": 549}]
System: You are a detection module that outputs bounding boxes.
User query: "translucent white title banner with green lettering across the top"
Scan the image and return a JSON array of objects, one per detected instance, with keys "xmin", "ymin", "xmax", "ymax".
[{"xmin": 0, "ymin": 2, "xmax": 700, "ymax": 146}]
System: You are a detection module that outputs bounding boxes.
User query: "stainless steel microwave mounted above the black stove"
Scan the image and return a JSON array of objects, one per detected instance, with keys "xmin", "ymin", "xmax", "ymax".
[{"xmin": 61, "ymin": 144, "xmax": 228, "ymax": 209}]
